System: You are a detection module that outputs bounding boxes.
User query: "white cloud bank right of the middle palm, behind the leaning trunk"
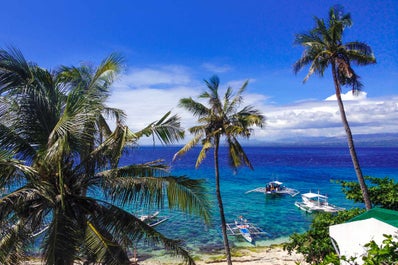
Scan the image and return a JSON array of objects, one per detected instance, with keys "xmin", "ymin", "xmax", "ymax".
[{"xmin": 257, "ymin": 94, "xmax": 398, "ymax": 141}]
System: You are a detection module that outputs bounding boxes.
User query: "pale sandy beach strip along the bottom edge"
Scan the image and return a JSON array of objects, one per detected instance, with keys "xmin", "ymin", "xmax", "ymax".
[{"xmin": 138, "ymin": 245, "xmax": 308, "ymax": 265}]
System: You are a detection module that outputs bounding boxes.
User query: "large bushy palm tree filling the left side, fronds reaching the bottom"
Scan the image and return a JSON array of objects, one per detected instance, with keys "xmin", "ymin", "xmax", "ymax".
[{"xmin": 0, "ymin": 49, "xmax": 209, "ymax": 265}]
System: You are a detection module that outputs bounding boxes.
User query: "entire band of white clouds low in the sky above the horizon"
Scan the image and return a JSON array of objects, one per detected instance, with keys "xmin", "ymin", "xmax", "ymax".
[{"xmin": 109, "ymin": 66, "xmax": 398, "ymax": 143}]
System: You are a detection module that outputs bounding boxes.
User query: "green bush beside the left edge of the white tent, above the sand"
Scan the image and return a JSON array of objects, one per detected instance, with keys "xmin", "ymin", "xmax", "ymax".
[{"xmin": 283, "ymin": 209, "xmax": 363, "ymax": 264}]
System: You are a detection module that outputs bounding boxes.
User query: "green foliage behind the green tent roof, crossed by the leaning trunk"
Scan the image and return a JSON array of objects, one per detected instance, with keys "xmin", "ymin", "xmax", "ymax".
[{"xmin": 338, "ymin": 176, "xmax": 398, "ymax": 210}]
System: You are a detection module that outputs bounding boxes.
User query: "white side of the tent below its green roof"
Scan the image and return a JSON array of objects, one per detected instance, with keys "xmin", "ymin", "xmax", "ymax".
[{"xmin": 329, "ymin": 218, "xmax": 398, "ymax": 264}]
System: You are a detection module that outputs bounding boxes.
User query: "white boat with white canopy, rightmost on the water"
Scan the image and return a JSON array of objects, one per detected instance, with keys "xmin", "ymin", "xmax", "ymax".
[{"xmin": 294, "ymin": 192, "xmax": 345, "ymax": 213}]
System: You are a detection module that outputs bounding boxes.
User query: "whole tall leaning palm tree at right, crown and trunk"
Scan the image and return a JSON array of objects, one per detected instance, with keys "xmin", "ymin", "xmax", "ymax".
[{"xmin": 293, "ymin": 7, "xmax": 376, "ymax": 210}]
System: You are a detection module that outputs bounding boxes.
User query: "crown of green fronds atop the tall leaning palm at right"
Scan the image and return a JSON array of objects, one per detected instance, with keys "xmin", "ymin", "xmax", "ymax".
[{"xmin": 293, "ymin": 7, "xmax": 376, "ymax": 91}]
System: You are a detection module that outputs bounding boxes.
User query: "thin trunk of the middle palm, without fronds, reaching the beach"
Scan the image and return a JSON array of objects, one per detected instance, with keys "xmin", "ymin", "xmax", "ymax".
[{"xmin": 214, "ymin": 135, "xmax": 232, "ymax": 265}]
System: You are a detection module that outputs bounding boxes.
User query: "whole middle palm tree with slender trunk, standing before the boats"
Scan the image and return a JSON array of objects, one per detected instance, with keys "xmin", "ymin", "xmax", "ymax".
[{"xmin": 174, "ymin": 76, "xmax": 265, "ymax": 264}]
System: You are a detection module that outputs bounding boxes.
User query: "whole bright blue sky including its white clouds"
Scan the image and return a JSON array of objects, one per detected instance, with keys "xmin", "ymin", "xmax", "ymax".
[{"xmin": 0, "ymin": 0, "xmax": 398, "ymax": 140}]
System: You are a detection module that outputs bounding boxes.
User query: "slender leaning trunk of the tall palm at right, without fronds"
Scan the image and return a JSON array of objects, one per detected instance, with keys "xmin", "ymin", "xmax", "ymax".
[{"xmin": 332, "ymin": 62, "xmax": 372, "ymax": 210}]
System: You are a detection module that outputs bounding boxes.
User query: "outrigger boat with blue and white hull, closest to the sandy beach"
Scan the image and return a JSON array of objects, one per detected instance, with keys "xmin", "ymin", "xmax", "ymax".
[{"xmin": 227, "ymin": 216, "xmax": 269, "ymax": 243}]
